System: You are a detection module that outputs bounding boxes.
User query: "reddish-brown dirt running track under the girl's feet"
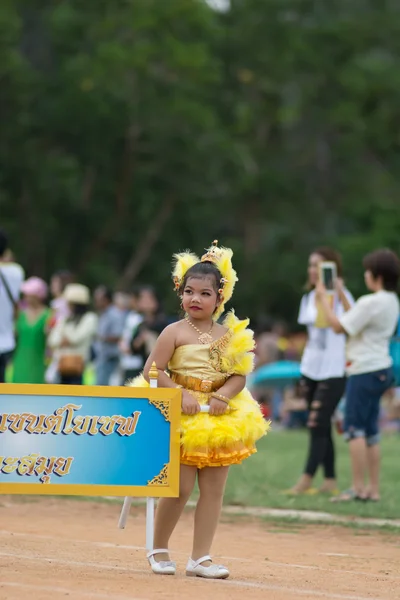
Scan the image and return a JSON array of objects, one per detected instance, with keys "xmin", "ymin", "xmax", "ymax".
[{"xmin": 0, "ymin": 496, "xmax": 400, "ymax": 600}]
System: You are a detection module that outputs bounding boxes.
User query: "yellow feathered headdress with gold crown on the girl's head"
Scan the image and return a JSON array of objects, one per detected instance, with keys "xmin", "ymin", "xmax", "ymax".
[{"xmin": 172, "ymin": 240, "xmax": 238, "ymax": 320}]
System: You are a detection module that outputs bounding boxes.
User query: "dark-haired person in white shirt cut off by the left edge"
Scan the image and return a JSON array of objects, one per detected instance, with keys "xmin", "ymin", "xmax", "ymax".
[{"xmin": 0, "ymin": 230, "xmax": 25, "ymax": 383}]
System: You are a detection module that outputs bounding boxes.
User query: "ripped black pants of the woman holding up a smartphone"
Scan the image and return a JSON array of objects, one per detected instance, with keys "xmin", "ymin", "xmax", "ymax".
[{"xmin": 300, "ymin": 377, "xmax": 346, "ymax": 479}]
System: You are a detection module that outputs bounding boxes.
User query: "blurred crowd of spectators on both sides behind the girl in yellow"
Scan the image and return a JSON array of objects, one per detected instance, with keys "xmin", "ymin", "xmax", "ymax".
[{"xmin": 0, "ymin": 231, "xmax": 399, "ymax": 500}]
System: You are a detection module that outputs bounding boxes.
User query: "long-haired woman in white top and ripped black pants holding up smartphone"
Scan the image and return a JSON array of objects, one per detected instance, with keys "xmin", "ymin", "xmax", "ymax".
[{"xmin": 289, "ymin": 247, "xmax": 354, "ymax": 495}]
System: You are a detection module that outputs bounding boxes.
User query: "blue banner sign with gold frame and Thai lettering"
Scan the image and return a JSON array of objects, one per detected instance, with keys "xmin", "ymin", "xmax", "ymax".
[{"xmin": 0, "ymin": 384, "xmax": 181, "ymax": 497}]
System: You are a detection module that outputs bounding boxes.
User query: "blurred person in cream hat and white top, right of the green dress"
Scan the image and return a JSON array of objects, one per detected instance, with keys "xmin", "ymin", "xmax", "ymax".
[{"xmin": 49, "ymin": 283, "xmax": 98, "ymax": 385}]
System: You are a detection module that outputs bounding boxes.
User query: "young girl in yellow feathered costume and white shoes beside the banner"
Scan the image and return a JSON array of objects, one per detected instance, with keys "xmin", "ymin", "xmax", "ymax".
[{"xmin": 130, "ymin": 242, "xmax": 269, "ymax": 579}]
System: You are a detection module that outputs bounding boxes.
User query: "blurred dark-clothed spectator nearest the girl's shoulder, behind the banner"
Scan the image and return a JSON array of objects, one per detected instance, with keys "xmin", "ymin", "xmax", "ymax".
[{"xmin": 131, "ymin": 285, "xmax": 171, "ymax": 364}]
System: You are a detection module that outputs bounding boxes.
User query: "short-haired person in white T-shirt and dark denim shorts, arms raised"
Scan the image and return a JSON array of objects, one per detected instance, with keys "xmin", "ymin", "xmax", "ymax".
[{"xmin": 317, "ymin": 249, "xmax": 400, "ymax": 501}]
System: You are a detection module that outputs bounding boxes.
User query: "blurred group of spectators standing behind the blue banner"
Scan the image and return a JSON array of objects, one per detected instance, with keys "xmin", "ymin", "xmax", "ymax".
[{"xmin": 0, "ymin": 231, "xmax": 171, "ymax": 385}]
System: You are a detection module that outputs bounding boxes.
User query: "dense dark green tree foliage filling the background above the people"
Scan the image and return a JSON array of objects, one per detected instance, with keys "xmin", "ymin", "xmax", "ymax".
[{"xmin": 0, "ymin": 0, "xmax": 400, "ymax": 320}]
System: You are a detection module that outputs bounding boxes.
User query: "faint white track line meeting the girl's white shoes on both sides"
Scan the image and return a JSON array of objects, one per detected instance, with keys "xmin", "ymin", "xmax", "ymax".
[{"xmin": 0, "ymin": 552, "xmax": 390, "ymax": 600}]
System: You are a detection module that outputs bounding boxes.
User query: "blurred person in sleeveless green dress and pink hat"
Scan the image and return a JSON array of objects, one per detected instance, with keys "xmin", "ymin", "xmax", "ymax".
[{"xmin": 12, "ymin": 277, "xmax": 51, "ymax": 383}]
